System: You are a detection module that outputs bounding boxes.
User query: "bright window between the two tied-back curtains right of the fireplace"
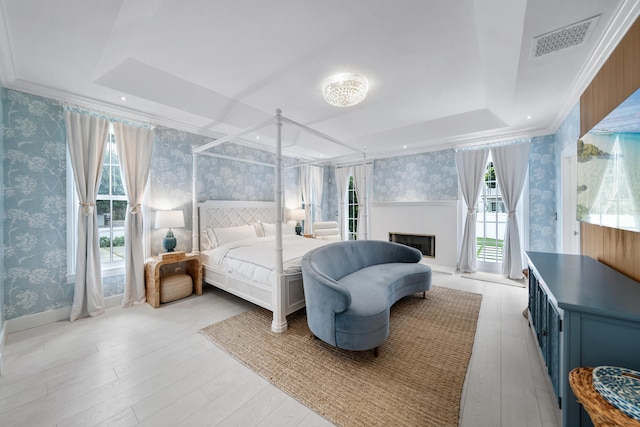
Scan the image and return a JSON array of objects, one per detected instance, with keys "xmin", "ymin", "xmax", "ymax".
[{"xmin": 476, "ymin": 160, "xmax": 507, "ymax": 263}]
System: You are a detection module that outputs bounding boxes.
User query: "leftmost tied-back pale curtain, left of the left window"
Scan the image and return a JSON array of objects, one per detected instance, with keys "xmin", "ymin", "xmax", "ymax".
[{"xmin": 64, "ymin": 110, "xmax": 109, "ymax": 321}]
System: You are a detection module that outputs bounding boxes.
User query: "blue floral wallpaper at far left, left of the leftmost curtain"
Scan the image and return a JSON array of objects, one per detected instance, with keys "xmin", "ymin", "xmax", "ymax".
[{"xmin": 2, "ymin": 90, "xmax": 68, "ymax": 319}]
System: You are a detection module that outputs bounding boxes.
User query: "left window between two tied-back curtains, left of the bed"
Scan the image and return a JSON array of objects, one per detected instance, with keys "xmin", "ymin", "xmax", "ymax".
[{"xmin": 96, "ymin": 132, "xmax": 127, "ymax": 265}]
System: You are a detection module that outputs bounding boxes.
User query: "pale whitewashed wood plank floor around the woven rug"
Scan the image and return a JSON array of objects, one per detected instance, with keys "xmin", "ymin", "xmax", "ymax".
[{"xmin": 0, "ymin": 273, "xmax": 561, "ymax": 427}]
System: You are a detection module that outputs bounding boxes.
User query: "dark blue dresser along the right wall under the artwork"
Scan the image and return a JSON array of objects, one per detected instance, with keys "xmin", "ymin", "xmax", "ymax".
[{"xmin": 527, "ymin": 252, "xmax": 640, "ymax": 426}]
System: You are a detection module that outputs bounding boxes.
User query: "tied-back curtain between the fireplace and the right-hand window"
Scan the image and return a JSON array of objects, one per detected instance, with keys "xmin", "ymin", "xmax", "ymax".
[{"xmin": 456, "ymin": 149, "xmax": 489, "ymax": 273}]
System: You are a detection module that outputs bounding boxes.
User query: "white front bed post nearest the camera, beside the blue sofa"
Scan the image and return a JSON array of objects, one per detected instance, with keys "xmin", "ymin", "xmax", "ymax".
[{"xmin": 271, "ymin": 109, "xmax": 287, "ymax": 333}]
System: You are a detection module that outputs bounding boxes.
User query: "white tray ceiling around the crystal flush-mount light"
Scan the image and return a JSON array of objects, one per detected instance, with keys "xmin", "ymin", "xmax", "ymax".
[{"xmin": 0, "ymin": 0, "xmax": 640, "ymax": 159}]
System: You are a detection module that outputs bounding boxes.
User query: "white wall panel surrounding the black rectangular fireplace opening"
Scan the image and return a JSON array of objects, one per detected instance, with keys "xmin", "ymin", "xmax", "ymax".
[{"xmin": 369, "ymin": 200, "xmax": 461, "ymax": 270}]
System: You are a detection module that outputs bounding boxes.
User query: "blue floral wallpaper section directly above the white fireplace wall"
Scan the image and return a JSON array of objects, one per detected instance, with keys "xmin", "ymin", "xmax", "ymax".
[{"xmin": 372, "ymin": 150, "xmax": 458, "ymax": 202}]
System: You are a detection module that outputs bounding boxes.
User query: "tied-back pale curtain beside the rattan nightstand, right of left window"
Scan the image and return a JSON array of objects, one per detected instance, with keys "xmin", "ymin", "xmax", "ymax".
[{"xmin": 113, "ymin": 122, "xmax": 153, "ymax": 307}]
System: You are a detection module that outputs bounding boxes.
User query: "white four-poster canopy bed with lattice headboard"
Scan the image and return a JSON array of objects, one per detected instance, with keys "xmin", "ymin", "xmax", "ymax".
[{"xmin": 192, "ymin": 110, "xmax": 368, "ymax": 333}]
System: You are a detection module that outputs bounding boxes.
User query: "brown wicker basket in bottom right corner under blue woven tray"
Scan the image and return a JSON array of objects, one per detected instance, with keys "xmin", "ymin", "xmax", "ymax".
[{"xmin": 569, "ymin": 368, "xmax": 640, "ymax": 427}]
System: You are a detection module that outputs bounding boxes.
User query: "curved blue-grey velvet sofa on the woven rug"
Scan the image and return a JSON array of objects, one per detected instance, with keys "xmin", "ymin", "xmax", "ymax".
[{"xmin": 302, "ymin": 240, "xmax": 431, "ymax": 355}]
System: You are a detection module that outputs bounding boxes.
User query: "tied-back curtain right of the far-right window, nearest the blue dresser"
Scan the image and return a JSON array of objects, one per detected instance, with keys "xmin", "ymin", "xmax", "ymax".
[{"xmin": 491, "ymin": 142, "xmax": 531, "ymax": 279}]
